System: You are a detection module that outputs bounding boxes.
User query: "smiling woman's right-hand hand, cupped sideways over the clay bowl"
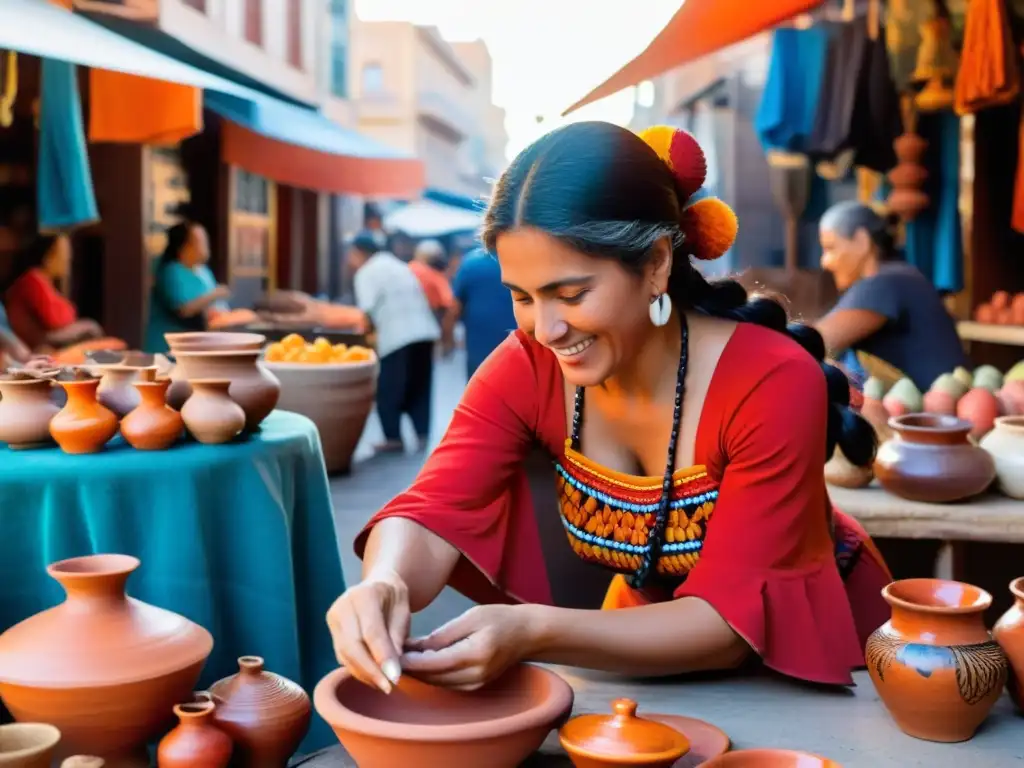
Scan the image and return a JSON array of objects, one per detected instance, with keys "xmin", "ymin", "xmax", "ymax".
[{"xmin": 401, "ymin": 605, "xmax": 532, "ymax": 690}]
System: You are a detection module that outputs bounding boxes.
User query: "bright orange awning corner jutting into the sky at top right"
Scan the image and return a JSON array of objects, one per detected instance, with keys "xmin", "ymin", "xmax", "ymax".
[{"xmin": 562, "ymin": 0, "xmax": 823, "ymax": 116}]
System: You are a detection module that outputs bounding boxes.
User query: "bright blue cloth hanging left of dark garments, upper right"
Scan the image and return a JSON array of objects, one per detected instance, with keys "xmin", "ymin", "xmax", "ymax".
[{"xmin": 754, "ymin": 27, "xmax": 828, "ymax": 153}]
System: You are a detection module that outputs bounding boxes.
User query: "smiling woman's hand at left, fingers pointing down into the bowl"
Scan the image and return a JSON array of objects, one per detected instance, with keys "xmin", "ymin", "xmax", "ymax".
[{"xmin": 327, "ymin": 572, "xmax": 412, "ymax": 693}]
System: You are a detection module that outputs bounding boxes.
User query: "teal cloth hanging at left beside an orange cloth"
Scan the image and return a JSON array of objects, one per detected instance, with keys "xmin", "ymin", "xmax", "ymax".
[{"xmin": 37, "ymin": 58, "xmax": 99, "ymax": 232}]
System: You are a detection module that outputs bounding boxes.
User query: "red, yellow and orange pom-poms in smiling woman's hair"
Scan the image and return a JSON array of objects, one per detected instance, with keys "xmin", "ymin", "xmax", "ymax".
[{"xmin": 639, "ymin": 125, "xmax": 739, "ymax": 261}]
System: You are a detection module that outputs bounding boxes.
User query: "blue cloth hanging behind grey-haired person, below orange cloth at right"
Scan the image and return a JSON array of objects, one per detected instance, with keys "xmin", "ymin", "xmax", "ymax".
[{"xmin": 905, "ymin": 113, "xmax": 964, "ymax": 292}]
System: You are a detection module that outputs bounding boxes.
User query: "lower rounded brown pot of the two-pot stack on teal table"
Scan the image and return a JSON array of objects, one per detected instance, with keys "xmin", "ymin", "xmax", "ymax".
[{"xmin": 175, "ymin": 350, "xmax": 281, "ymax": 432}]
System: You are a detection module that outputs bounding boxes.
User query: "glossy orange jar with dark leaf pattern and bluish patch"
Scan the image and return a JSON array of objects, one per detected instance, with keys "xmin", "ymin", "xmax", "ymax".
[{"xmin": 864, "ymin": 579, "xmax": 1007, "ymax": 741}]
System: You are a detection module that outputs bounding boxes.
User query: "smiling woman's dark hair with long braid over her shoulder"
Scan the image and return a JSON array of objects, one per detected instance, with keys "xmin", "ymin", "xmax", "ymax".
[{"xmin": 482, "ymin": 122, "xmax": 876, "ymax": 586}]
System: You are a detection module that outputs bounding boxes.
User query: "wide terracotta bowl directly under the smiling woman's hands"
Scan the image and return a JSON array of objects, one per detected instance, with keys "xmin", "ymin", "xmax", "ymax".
[{"xmin": 313, "ymin": 665, "xmax": 572, "ymax": 768}]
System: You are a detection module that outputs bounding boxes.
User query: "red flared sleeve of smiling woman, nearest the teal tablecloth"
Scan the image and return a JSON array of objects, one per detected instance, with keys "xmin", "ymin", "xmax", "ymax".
[{"xmin": 355, "ymin": 334, "xmax": 561, "ymax": 603}]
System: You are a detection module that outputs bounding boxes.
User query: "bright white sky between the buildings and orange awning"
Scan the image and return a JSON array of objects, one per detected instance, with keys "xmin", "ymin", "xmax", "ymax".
[{"xmin": 355, "ymin": 0, "xmax": 681, "ymax": 157}]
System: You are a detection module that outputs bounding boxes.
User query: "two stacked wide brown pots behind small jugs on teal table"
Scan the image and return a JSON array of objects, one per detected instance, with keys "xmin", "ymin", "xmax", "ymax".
[{"xmin": 165, "ymin": 332, "xmax": 281, "ymax": 434}]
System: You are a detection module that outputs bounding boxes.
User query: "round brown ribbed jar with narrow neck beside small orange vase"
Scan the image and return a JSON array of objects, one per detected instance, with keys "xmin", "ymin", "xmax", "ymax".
[{"xmin": 210, "ymin": 656, "xmax": 312, "ymax": 768}]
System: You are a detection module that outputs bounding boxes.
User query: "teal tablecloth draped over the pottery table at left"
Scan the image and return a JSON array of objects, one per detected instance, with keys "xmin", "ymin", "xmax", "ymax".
[{"xmin": 0, "ymin": 411, "xmax": 344, "ymax": 751}]
